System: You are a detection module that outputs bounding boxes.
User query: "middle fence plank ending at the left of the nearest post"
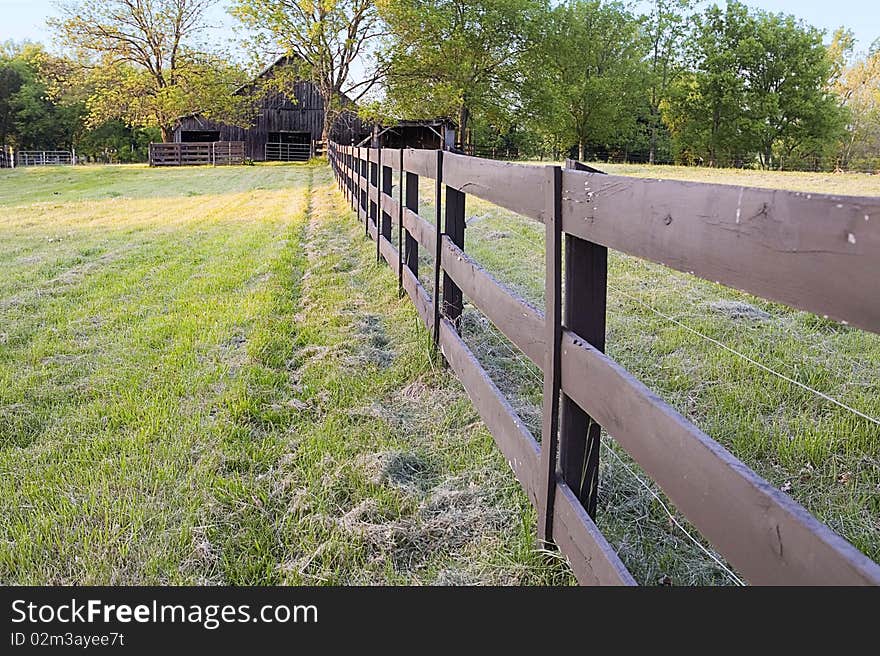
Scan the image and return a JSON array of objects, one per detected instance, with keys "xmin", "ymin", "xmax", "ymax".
[{"xmin": 438, "ymin": 236, "xmax": 547, "ymax": 370}]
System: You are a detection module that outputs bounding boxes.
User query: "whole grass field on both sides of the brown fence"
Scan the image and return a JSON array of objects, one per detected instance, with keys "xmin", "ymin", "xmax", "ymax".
[{"xmin": 0, "ymin": 160, "xmax": 880, "ymax": 584}]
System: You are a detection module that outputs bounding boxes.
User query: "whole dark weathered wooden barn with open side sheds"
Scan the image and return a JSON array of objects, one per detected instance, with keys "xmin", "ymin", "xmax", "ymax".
[{"xmin": 174, "ymin": 57, "xmax": 372, "ymax": 161}]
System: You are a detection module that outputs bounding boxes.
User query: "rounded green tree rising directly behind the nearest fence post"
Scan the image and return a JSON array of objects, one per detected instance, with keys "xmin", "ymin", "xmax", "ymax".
[{"xmin": 527, "ymin": 0, "xmax": 648, "ymax": 159}]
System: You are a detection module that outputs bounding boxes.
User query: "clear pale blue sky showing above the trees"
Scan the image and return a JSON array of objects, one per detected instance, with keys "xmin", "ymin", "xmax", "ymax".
[{"xmin": 0, "ymin": 0, "xmax": 880, "ymax": 50}]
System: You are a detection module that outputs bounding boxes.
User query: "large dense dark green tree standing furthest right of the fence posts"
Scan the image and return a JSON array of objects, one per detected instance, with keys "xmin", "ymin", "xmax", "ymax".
[{"xmin": 662, "ymin": 2, "xmax": 844, "ymax": 167}]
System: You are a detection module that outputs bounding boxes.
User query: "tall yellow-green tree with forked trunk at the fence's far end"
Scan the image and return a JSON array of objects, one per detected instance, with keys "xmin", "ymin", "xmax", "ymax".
[{"xmin": 232, "ymin": 0, "xmax": 382, "ymax": 142}]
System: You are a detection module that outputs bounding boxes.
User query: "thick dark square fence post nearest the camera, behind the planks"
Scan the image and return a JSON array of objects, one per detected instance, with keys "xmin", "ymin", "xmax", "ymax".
[{"xmin": 559, "ymin": 161, "xmax": 608, "ymax": 517}]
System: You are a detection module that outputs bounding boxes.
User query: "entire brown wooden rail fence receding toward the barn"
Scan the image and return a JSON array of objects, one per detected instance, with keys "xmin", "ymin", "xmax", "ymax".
[{"xmin": 328, "ymin": 144, "xmax": 880, "ymax": 585}]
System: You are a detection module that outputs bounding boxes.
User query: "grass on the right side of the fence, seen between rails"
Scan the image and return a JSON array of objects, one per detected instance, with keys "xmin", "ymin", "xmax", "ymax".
[{"xmin": 408, "ymin": 163, "xmax": 880, "ymax": 584}]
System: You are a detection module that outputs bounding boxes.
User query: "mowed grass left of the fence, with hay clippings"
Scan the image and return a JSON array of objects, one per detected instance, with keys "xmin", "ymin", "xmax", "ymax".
[{"xmin": 0, "ymin": 165, "xmax": 572, "ymax": 584}]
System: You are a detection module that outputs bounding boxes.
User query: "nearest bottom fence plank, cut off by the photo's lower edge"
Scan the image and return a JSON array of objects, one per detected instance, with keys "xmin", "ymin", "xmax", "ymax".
[{"xmin": 553, "ymin": 481, "xmax": 637, "ymax": 585}]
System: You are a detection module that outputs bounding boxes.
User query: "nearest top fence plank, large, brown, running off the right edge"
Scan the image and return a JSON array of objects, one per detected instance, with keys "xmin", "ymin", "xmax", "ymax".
[{"xmin": 562, "ymin": 171, "xmax": 880, "ymax": 332}]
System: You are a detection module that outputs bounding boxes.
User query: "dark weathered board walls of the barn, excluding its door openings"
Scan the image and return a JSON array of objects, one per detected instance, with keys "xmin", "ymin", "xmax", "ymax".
[{"xmin": 174, "ymin": 82, "xmax": 370, "ymax": 161}]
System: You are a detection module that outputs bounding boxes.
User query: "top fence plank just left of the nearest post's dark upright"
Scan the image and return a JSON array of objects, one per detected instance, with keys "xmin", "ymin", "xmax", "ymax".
[{"xmin": 443, "ymin": 153, "xmax": 549, "ymax": 222}]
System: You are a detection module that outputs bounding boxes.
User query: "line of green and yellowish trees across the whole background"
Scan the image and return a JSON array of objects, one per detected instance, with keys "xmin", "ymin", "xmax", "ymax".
[{"xmin": 0, "ymin": 0, "xmax": 880, "ymax": 169}]
